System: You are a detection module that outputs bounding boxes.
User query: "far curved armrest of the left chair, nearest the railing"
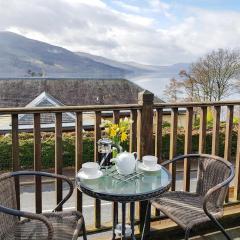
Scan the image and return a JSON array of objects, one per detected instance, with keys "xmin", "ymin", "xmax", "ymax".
[{"xmin": 4, "ymin": 171, "xmax": 74, "ymax": 212}]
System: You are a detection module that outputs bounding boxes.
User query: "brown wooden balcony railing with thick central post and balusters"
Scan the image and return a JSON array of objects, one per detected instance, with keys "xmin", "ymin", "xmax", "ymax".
[{"xmin": 0, "ymin": 91, "xmax": 240, "ymax": 235}]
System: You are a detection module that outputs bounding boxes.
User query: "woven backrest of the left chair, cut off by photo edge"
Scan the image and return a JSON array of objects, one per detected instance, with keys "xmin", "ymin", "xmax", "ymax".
[{"xmin": 0, "ymin": 174, "xmax": 18, "ymax": 239}]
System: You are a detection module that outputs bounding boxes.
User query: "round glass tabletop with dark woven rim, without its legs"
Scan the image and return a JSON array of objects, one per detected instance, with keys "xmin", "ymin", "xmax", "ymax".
[{"xmin": 76, "ymin": 164, "xmax": 171, "ymax": 201}]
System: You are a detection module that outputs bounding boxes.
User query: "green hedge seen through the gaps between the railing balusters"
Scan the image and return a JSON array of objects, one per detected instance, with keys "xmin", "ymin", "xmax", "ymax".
[{"xmin": 0, "ymin": 129, "xmax": 237, "ymax": 170}]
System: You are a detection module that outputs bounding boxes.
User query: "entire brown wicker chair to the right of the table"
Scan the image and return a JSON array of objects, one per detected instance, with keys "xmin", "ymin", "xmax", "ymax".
[{"xmin": 151, "ymin": 154, "xmax": 234, "ymax": 240}]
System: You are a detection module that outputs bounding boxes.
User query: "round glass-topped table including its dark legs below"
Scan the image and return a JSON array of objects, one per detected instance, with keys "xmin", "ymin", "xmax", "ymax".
[{"xmin": 76, "ymin": 167, "xmax": 172, "ymax": 239}]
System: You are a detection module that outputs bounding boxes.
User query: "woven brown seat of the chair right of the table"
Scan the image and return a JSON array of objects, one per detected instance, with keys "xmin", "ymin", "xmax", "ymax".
[{"xmin": 152, "ymin": 191, "xmax": 222, "ymax": 230}]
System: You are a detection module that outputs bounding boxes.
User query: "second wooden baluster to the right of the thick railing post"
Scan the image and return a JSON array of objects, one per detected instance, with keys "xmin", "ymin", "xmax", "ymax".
[{"xmin": 169, "ymin": 108, "xmax": 178, "ymax": 191}]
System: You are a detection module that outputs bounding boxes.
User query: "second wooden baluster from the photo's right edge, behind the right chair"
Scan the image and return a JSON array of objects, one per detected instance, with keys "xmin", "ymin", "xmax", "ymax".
[{"xmin": 224, "ymin": 105, "xmax": 234, "ymax": 202}]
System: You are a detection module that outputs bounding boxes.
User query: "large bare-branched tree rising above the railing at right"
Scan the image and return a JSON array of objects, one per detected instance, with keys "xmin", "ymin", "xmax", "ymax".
[{"xmin": 180, "ymin": 49, "xmax": 240, "ymax": 101}]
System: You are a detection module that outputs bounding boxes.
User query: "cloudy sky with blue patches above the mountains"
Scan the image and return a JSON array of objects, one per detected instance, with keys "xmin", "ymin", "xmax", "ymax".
[{"xmin": 0, "ymin": 0, "xmax": 240, "ymax": 65}]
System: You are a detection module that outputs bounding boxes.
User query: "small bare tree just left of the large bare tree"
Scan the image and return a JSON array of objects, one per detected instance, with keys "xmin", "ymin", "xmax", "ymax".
[{"xmin": 164, "ymin": 78, "xmax": 183, "ymax": 102}]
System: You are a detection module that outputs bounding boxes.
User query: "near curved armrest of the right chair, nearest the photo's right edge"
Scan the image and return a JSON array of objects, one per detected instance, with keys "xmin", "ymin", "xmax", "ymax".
[{"xmin": 203, "ymin": 165, "xmax": 235, "ymax": 216}]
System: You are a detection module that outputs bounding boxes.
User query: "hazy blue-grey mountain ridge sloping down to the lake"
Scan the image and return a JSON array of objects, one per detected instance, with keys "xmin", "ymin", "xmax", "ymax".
[{"xmin": 0, "ymin": 32, "xmax": 189, "ymax": 79}]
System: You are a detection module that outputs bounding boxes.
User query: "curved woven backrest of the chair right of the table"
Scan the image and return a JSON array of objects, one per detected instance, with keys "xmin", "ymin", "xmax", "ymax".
[{"xmin": 196, "ymin": 155, "xmax": 231, "ymax": 207}]
